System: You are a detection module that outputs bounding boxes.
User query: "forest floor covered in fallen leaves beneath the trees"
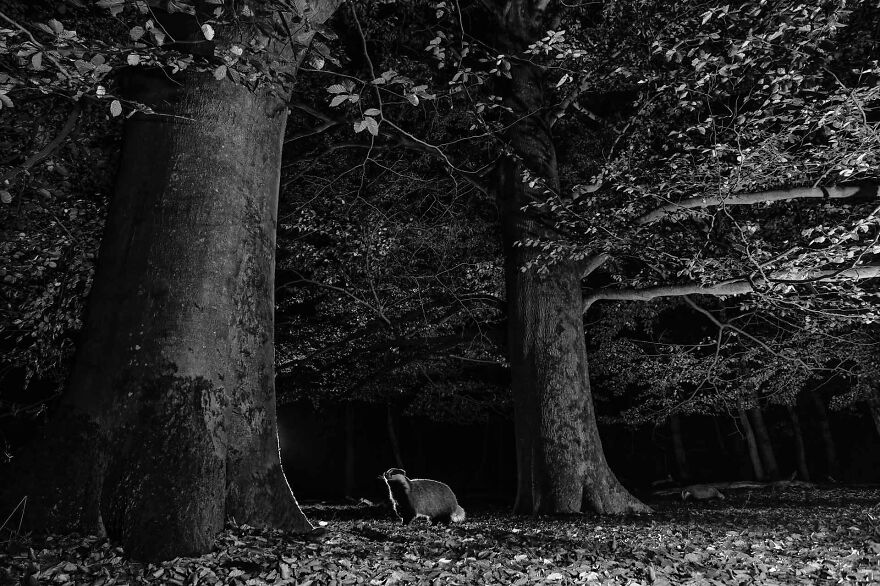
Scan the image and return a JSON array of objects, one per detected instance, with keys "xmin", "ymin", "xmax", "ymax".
[{"xmin": 0, "ymin": 488, "xmax": 880, "ymax": 586}]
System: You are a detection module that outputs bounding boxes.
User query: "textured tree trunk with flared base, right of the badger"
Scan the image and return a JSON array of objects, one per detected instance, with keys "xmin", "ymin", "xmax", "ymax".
[{"xmin": 495, "ymin": 63, "xmax": 650, "ymax": 513}]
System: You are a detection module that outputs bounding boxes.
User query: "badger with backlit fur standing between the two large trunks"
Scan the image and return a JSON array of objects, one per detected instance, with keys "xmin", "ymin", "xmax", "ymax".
[{"xmin": 381, "ymin": 468, "xmax": 464, "ymax": 524}]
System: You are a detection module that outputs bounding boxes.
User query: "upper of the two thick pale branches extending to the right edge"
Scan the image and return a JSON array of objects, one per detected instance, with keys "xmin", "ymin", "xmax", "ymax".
[{"xmin": 636, "ymin": 185, "xmax": 880, "ymax": 225}]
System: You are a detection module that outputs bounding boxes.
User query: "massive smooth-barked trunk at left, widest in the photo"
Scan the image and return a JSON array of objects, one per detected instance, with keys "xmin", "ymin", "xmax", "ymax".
[{"xmin": 5, "ymin": 71, "xmax": 311, "ymax": 560}]
